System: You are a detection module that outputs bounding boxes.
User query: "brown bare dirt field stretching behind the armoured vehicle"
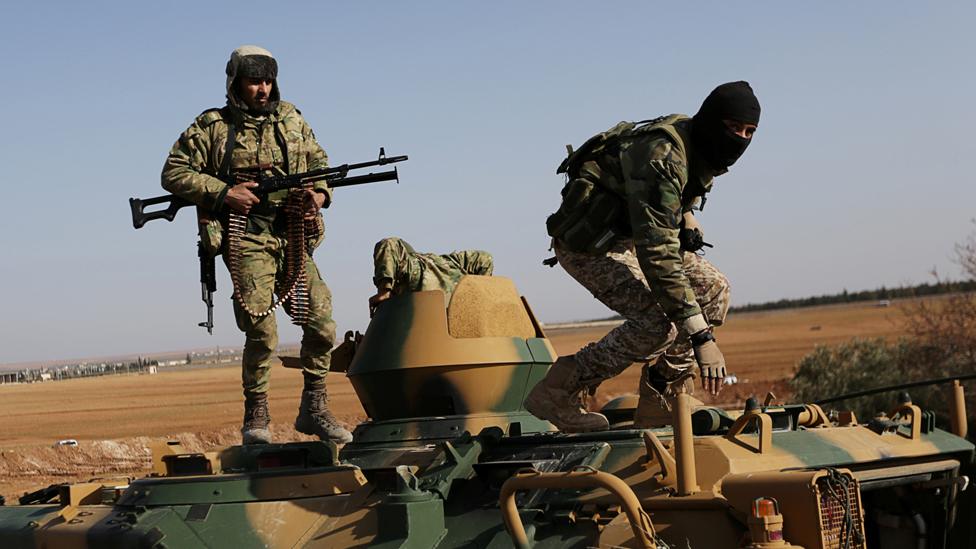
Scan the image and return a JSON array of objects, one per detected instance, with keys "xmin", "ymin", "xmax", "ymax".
[{"xmin": 0, "ymin": 301, "xmax": 906, "ymax": 503}]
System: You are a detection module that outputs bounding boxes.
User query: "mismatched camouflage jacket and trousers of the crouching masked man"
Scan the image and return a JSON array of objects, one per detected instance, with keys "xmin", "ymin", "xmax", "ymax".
[{"xmin": 554, "ymin": 116, "xmax": 729, "ymax": 383}]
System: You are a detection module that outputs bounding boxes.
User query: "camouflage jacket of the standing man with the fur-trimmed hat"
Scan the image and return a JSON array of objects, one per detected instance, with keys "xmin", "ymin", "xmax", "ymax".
[{"xmin": 162, "ymin": 101, "xmax": 331, "ymax": 222}]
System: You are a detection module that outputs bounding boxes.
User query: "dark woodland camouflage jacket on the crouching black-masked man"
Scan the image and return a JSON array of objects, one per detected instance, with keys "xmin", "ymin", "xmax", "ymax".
[{"xmin": 569, "ymin": 116, "xmax": 713, "ymax": 322}]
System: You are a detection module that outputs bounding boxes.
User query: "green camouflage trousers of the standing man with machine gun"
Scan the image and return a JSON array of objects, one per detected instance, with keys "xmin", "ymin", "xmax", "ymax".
[{"xmin": 224, "ymin": 231, "xmax": 335, "ymax": 395}]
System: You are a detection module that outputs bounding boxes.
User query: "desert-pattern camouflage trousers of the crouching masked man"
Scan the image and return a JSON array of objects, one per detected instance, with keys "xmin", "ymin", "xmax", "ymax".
[{"xmin": 555, "ymin": 240, "xmax": 730, "ymax": 385}]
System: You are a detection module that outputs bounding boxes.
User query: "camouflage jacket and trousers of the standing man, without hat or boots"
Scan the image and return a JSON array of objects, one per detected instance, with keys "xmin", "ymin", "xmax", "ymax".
[{"xmin": 163, "ymin": 101, "xmax": 335, "ymax": 394}]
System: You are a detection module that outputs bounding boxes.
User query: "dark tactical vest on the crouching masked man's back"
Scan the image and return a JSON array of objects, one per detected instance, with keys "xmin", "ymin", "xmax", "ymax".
[{"xmin": 546, "ymin": 114, "xmax": 687, "ymax": 255}]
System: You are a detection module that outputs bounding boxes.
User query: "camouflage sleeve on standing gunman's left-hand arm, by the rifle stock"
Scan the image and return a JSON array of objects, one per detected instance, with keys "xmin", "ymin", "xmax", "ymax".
[{"xmin": 162, "ymin": 119, "xmax": 227, "ymax": 211}]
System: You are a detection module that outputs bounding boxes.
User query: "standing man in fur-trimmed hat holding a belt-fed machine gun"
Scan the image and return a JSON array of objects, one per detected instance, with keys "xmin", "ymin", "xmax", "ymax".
[{"xmin": 162, "ymin": 46, "xmax": 352, "ymax": 444}]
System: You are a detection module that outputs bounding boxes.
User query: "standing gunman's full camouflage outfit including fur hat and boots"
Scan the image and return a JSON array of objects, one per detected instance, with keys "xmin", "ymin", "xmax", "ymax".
[{"xmin": 162, "ymin": 46, "xmax": 351, "ymax": 444}]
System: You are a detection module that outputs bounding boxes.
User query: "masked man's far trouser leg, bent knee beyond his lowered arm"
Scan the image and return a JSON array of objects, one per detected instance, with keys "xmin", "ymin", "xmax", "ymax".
[{"xmin": 650, "ymin": 252, "xmax": 731, "ymax": 380}]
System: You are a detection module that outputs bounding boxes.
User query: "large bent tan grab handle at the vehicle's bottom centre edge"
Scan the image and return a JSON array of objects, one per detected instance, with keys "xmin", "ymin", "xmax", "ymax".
[{"xmin": 498, "ymin": 468, "xmax": 657, "ymax": 549}]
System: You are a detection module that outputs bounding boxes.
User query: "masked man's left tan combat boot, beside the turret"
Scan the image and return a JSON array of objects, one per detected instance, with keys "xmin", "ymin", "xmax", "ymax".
[{"xmin": 525, "ymin": 355, "xmax": 610, "ymax": 433}]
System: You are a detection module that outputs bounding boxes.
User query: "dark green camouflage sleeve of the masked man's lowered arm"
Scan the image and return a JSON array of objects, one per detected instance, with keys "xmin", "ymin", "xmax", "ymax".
[{"xmin": 620, "ymin": 138, "xmax": 701, "ymax": 322}]
